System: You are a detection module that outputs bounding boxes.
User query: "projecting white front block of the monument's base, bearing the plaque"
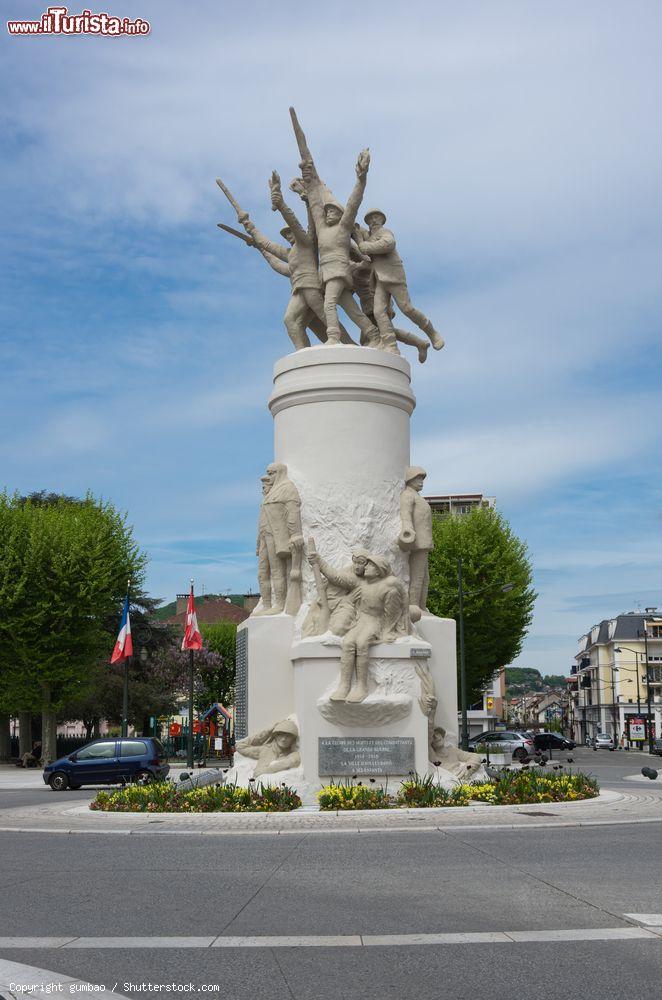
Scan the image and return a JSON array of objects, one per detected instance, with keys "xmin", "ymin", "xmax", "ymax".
[{"xmin": 291, "ymin": 636, "xmax": 431, "ymax": 784}]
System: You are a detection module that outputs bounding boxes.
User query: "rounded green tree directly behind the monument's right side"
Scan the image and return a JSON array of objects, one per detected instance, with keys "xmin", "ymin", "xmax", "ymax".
[{"xmin": 428, "ymin": 508, "xmax": 537, "ymax": 704}]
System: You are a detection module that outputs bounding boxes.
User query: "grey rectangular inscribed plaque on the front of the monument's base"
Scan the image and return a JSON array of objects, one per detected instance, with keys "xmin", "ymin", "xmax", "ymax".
[{"xmin": 318, "ymin": 736, "xmax": 416, "ymax": 777}]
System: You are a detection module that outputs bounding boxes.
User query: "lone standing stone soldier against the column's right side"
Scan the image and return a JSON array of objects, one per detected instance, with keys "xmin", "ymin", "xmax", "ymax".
[{"xmin": 398, "ymin": 465, "xmax": 434, "ymax": 617}]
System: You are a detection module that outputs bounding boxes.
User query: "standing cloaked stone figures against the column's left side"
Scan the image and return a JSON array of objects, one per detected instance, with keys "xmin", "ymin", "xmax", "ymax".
[{"xmin": 253, "ymin": 462, "xmax": 303, "ymax": 616}]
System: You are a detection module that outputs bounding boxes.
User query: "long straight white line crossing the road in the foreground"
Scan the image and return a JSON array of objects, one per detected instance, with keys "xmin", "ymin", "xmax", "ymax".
[{"xmin": 0, "ymin": 924, "xmax": 662, "ymax": 950}]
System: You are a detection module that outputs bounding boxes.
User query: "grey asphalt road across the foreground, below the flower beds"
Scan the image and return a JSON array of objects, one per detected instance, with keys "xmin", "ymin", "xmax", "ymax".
[{"xmin": 0, "ymin": 824, "xmax": 662, "ymax": 1000}]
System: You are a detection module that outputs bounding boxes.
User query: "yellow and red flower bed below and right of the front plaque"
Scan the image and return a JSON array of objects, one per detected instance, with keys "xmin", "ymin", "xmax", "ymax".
[{"xmin": 317, "ymin": 768, "xmax": 600, "ymax": 812}]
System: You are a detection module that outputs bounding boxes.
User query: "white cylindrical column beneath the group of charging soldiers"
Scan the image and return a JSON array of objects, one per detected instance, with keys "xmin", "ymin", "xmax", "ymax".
[{"xmin": 269, "ymin": 345, "xmax": 416, "ymax": 599}]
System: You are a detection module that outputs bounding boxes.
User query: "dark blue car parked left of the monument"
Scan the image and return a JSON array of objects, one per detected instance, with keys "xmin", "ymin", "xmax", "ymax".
[{"xmin": 44, "ymin": 736, "xmax": 170, "ymax": 792}]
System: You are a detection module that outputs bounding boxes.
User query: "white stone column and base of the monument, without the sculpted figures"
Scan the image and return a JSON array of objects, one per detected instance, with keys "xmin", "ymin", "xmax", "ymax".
[{"xmin": 237, "ymin": 345, "xmax": 457, "ymax": 784}]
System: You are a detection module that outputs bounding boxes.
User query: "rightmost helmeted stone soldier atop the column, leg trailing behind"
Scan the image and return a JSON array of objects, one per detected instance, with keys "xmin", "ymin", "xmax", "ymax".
[{"xmin": 358, "ymin": 208, "xmax": 444, "ymax": 351}]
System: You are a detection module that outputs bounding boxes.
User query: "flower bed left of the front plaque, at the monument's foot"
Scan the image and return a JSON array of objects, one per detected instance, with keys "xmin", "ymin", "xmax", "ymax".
[{"xmin": 90, "ymin": 781, "xmax": 301, "ymax": 813}]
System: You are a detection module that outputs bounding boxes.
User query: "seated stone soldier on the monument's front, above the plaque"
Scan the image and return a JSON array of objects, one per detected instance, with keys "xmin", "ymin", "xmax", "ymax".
[{"xmin": 308, "ymin": 546, "xmax": 411, "ymax": 702}]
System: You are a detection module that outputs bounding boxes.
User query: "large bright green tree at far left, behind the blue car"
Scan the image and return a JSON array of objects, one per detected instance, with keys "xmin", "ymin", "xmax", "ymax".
[{"xmin": 0, "ymin": 492, "xmax": 146, "ymax": 760}]
